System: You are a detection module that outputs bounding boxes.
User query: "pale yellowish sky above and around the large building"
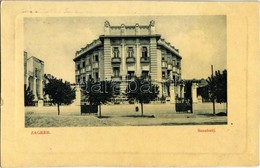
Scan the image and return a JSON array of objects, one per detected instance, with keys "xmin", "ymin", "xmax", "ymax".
[{"xmin": 24, "ymin": 15, "xmax": 227, "ymax": 83}]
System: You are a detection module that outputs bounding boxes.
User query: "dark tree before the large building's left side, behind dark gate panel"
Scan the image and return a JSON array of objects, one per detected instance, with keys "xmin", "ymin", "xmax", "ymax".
[{"xmin": 81, "ymin": 79, "xmax": 120, "ymax": 117}]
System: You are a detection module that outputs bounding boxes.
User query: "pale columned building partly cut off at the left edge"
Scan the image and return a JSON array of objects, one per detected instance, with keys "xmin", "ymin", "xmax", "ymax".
[{"xmin": 24, "ymin": 52, "xmax": 44, "ymax": 102}]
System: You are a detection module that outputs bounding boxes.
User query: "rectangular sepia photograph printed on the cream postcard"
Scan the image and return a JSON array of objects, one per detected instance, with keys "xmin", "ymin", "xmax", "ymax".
[{"xmin": 24, "ymin": 15, "xmax": 228, "ymax": 127}]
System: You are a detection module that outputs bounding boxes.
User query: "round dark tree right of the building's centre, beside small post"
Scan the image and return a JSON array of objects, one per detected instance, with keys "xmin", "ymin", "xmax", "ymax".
[{"xmin": 126, "ymin": 77, "xmax": 159, "ymax": 116}]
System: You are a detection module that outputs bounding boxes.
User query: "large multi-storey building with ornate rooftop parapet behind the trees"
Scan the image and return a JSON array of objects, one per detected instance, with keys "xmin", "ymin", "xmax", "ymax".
[{"xmin": 73, "ymin": 21, "xmax": 184, "ymax": 103}]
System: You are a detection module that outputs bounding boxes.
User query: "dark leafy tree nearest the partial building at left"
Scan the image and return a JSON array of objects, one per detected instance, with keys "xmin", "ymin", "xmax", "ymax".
[{"xmin": 44, "ymin": 75, "xmax": 76, "ymax": 115}]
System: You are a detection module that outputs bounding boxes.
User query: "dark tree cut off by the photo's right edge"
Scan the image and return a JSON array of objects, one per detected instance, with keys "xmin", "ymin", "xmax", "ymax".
[{"xmin": 207, "ymin": 70, "xmax": 227, "ymax": 114}]
